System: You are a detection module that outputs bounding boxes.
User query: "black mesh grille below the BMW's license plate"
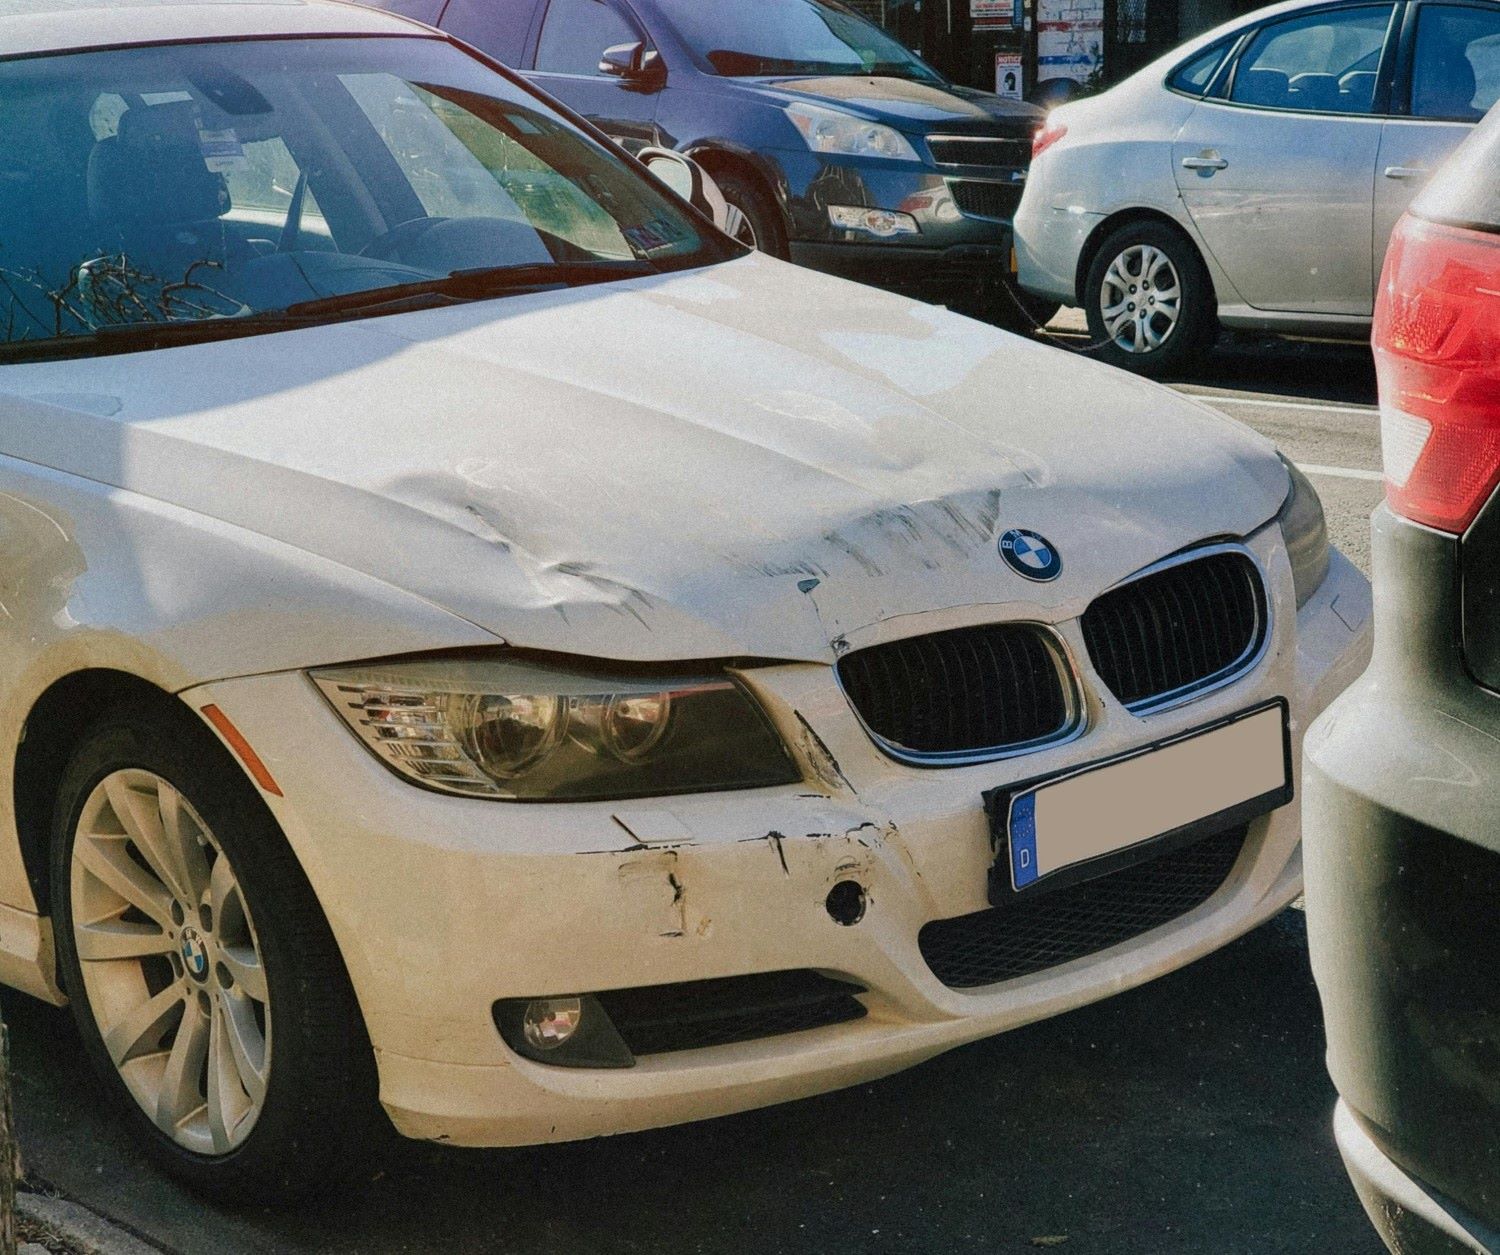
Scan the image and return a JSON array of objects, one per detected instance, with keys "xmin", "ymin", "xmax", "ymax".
[{"xmin": 918, "ymin": 826, "xmax": 1247, "ymax": 990}]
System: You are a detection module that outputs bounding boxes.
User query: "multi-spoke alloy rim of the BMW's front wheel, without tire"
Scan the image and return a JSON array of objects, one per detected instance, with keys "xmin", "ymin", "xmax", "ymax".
[{"xmin": 69, "ymin": 771, "xmax": 272, "ymax": 1156}]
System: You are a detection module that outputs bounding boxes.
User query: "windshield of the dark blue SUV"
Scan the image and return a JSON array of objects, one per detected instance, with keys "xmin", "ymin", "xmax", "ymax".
[{"xmin": 657, "ymin": 0, "xmax": 944, "ymax": 85}]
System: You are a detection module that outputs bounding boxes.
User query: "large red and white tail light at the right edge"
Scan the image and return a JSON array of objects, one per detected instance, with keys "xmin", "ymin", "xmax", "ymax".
[{"xmin": 1374, "ymin": 216, "xmax": 1500, "ymax": 534}]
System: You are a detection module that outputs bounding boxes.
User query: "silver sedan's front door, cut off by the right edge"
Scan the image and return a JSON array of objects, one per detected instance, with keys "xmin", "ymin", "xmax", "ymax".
[{"xmin": 1374, "ymin": 0, "xmax": 1500, "ymax": 262}]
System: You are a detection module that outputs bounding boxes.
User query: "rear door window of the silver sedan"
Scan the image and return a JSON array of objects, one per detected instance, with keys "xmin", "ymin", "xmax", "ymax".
[{"xmin": 1230, "ymin": 4, "xmax": 1391, "ymax": 114}]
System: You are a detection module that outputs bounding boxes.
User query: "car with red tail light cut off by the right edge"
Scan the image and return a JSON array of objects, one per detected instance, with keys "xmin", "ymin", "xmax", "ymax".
[{"xmin": 1305, "ymin": 114, "xmax": 1500, "ymax": 1255}]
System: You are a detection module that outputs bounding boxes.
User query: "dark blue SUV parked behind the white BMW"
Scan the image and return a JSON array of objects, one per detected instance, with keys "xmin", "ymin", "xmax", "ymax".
[{"xmin": 375, "ymin": 0, "xmax": 1058, "ymax": 330}]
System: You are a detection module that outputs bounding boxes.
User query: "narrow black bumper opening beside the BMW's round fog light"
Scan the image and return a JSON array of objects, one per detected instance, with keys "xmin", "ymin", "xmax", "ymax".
[{"xmin": 596, "ymin": 972, "xmax": 866, "ymax": 1056}]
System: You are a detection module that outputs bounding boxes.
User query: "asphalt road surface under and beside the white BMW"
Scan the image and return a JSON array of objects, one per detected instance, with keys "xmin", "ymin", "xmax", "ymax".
[{"xmin": 3, "ymin": 328, "xmax": 1382, "ymax": 1255}]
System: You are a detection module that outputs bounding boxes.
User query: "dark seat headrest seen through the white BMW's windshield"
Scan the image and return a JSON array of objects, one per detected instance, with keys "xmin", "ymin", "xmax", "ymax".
[{"xmin": 89, "ymin": 100, "xmax": 228, "ymax": 228}]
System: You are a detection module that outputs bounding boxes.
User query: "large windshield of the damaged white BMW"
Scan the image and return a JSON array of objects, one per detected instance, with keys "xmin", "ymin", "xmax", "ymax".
[{"xmin": 0, "ymin": 37, "xmax": 738, "ymax": 358}]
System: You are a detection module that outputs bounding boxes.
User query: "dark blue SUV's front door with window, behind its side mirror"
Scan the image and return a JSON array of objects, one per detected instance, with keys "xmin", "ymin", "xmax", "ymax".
[{"xmin": 528, "ymin": 0, "xmax": 665, "ymax": 151}]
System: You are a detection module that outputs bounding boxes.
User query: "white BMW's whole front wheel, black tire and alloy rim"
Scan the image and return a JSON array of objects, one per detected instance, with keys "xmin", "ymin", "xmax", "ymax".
[{"xmin": 51, "ymin": 709, "xmax": 380, "ymax": 1204}]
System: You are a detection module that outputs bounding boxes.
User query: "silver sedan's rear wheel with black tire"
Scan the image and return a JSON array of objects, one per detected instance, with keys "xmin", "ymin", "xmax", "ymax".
[{"xmin": 1083, "ymin": 222, "xmax": 1218, "ymax": 376}]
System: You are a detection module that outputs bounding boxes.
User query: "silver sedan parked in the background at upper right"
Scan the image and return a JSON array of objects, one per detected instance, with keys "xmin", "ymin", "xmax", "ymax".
[{"xmin": 1016, "ymin": 0, "xmax": 1500, "ymax": 373}]
